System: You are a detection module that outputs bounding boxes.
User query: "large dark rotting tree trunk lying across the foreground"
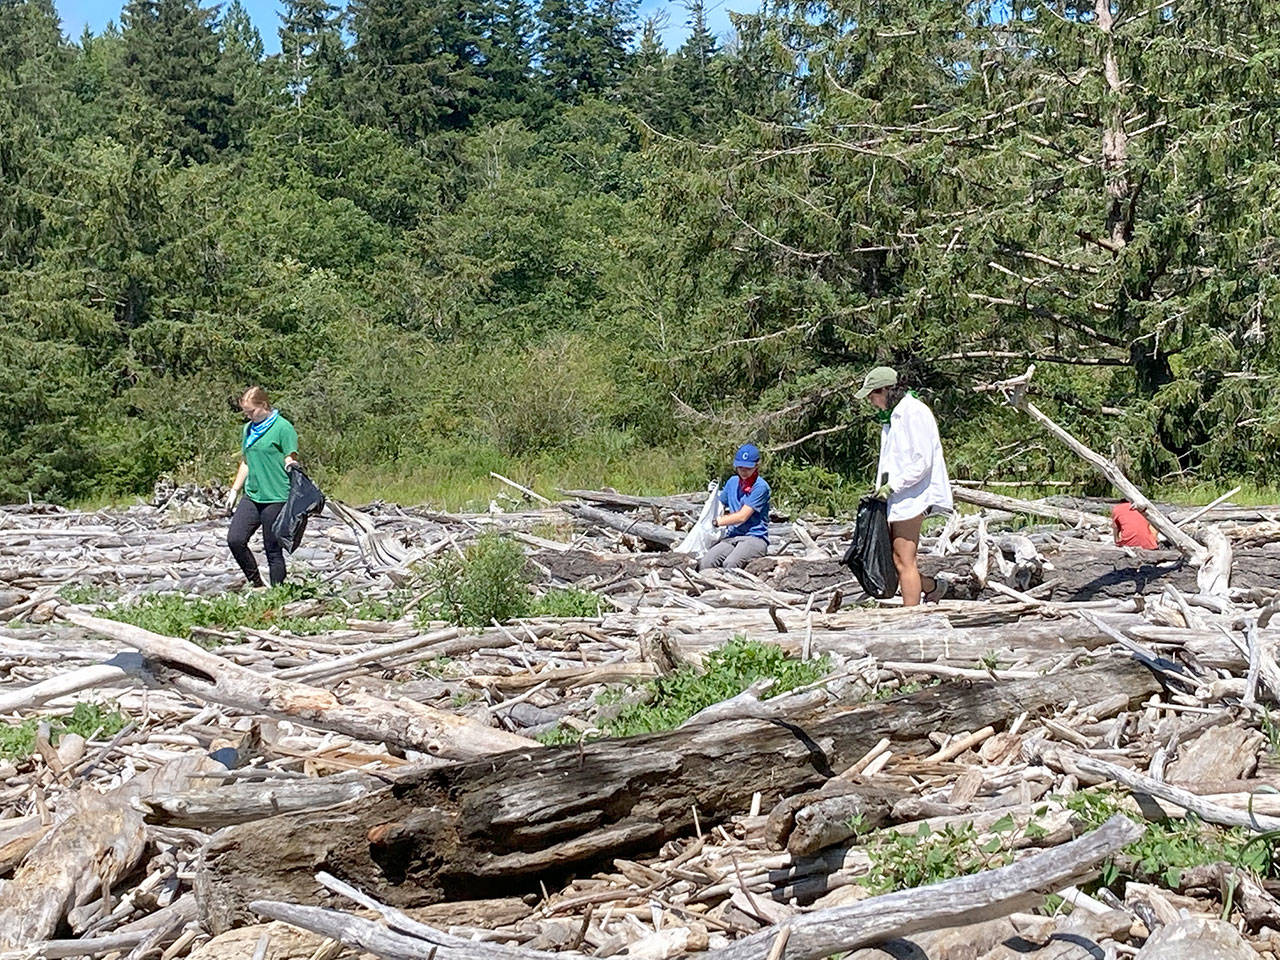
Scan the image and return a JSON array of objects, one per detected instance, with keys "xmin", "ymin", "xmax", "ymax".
[{"xmin": 196, "ymin": 658, "xmax": 1158, "ymax": 931}]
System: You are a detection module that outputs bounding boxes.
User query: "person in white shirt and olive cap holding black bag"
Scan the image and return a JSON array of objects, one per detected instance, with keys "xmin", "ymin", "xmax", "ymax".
[{"xmin": 855, "ymin": 366, "xmax": 955, "ymax": 607}]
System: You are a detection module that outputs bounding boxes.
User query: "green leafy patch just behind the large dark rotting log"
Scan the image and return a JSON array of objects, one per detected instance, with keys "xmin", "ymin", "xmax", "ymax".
[{"xmin": 539, "ymin": 636, "xmax": 831, "ymax": 744}]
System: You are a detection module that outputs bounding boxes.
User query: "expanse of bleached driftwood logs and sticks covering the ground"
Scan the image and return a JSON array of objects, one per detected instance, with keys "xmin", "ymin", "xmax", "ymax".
[{"xmin": 0, "ymin": 471, "xmax": 1280, "ymax": 960}]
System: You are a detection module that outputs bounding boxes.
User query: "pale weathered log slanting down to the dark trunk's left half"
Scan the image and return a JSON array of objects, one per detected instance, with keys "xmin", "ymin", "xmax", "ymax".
[{"xmin": 59, "ymin": 607, "xmax": 540, "ymax": 759}]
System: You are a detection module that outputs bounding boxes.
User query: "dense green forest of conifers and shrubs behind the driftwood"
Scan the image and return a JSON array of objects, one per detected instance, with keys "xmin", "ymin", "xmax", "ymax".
[{"xmin": 0, "ymin": 0, "xmax": 1280, "ymax": 502}]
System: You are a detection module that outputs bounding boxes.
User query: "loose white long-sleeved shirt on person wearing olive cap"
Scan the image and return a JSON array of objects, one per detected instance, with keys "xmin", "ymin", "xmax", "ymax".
[{"xmin": 876, "ymin": 394, "xmax": 955, "ymax": 522}]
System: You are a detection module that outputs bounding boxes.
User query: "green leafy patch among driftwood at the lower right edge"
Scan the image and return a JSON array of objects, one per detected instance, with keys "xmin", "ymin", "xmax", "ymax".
[{"xmin": 1066, "ymin": 790, "xmax": 1280, "ymax": 887}]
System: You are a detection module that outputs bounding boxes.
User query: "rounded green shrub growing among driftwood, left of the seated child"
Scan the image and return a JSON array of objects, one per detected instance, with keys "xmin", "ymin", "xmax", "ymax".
[{"xmin": 422, "ymin": 534, "xmax": 530, "ymax": 627}]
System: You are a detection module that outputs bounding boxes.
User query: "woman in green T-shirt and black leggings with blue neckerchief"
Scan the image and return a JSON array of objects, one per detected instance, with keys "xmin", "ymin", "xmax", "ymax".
[{"xmin": 227, "ymin": 387, "xmax": 298, "ymax": 586}]
